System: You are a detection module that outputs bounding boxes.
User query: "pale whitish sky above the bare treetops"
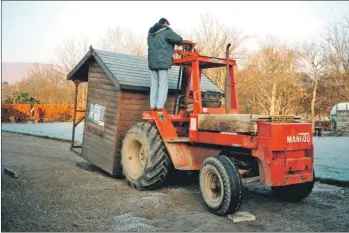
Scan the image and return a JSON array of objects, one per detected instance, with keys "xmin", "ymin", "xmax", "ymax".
[{"xmin": 1, "ymin": 1, "xmax": 349, "ymax": 64}]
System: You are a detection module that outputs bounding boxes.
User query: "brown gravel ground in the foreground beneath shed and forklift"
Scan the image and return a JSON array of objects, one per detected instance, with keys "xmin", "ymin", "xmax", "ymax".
[{"xmin": 1, "ymin": 132, "xmax": 349, "ymax": 232}]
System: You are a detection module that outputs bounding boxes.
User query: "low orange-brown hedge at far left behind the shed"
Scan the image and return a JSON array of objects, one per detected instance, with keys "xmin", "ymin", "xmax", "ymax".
[{"xmin": 1, "ymin": 104, "xmax": 85, "ymax": 122}]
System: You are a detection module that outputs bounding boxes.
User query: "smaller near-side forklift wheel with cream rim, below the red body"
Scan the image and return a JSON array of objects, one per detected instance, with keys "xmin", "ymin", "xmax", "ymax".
[{"xmin": 200, "ymin": 155, "xmax": 243, "ymax": 216}]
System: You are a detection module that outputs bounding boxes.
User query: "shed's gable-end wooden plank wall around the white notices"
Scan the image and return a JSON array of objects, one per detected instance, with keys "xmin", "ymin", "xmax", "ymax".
[{"xmin": 82, "ymin": 63, "xmax": 121, "ymax": 174}]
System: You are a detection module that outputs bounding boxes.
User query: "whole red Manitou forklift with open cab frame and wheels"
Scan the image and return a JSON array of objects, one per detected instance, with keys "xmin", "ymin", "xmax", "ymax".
[{"xmin": 121, "ymin": 41, "xmax": 314, "ymax": 216}]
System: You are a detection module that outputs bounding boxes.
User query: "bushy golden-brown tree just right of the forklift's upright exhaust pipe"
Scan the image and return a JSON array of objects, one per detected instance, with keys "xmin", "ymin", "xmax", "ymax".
[{"xmin": 237, "ymin": 38, "xmax": 303, "ymax": 115}]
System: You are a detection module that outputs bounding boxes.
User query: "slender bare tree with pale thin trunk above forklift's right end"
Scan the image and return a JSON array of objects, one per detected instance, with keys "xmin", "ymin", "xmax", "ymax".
[{"xmin": 300, "ymin": 43, "xmax": 325, "ymax": 132}]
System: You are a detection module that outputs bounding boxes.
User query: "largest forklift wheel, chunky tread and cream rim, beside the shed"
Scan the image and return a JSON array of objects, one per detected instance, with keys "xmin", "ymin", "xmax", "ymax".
[{"xmin": 121, "ymin": 122, "xmax": 173, "ymax": 190}]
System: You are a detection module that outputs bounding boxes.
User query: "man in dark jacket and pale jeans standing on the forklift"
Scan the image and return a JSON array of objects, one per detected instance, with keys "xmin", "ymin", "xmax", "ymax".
[{"xmin": 147, "ymin": 18, "xmax": 183, "ymax": 111}]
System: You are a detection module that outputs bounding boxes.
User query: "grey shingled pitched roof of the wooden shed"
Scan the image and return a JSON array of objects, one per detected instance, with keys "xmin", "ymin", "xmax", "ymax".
[{"xmin": 67, "ymin": 47, "xmax": 223, "ymax": 93}]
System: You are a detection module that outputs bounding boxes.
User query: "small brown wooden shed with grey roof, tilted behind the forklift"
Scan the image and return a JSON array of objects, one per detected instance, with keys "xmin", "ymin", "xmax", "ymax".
[{"xmin": 67, "ymin": 47, "xmax": 222, "ymax": 175}]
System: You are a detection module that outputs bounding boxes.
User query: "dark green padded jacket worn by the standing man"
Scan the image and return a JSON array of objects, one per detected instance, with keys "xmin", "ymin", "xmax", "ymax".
[{"xmin": 148, "ymin": 23, "xmax": 183, "ymax": 70}]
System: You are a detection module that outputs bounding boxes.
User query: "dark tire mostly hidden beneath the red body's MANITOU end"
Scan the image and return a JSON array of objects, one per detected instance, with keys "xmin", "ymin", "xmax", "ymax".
[{"xmin": 272, "ymin": 171, "xmax": 315, "ymax": 202}]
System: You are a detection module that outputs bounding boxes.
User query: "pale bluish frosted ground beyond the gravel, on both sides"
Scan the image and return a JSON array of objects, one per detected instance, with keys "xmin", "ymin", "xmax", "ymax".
[{"xmin": 1, "ymin": 122, "xmax": 349, "ymax": 182}]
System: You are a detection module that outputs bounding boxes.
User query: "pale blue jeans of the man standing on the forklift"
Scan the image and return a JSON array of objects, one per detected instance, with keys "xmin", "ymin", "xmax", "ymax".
[{"xmin": 150, "ymin": 70, "xmax": 168, "ymax": 109}]
